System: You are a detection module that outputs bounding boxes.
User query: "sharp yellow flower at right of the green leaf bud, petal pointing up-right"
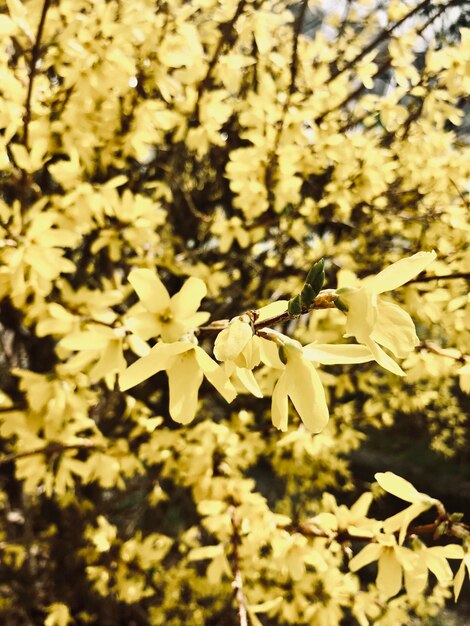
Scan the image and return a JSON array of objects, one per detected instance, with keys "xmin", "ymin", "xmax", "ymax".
[{"xmin": 339, "ymin": 252, "xmax": 436, "ymax": 376}]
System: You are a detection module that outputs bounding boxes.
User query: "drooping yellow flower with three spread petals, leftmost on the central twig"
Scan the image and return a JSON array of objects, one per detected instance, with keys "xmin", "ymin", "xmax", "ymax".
[{"xmin": 119, "ymin": 341, "xmax": 237, "ymax": 424}]
